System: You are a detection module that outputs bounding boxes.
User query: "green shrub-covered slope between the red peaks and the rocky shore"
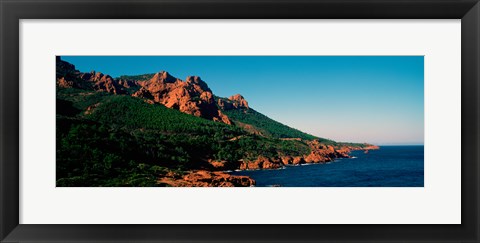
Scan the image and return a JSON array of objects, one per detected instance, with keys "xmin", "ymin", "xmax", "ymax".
[{"xmin": 56, "ymin": 88, "xmax": 310, "ymax": 186}]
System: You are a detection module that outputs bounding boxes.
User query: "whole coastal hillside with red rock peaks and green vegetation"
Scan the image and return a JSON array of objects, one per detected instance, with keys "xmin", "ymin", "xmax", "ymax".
[{"xmin": 56, "ymin": 58, "xmax": 376, "ymax": 186}]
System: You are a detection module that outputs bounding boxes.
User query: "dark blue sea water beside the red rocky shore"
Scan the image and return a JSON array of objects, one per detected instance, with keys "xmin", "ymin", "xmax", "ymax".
[{"xmin": 231, "ymin": 146, "xmax": 424, "ymax": 187}]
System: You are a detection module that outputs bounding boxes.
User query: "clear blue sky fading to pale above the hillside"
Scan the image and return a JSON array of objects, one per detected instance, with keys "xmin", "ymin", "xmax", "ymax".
[{"xmin": 62, "ymin": 56, "xmax": 424, "ymax": 145}]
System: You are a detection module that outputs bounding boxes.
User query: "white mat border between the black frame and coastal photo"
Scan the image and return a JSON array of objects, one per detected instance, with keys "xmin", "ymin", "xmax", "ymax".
[{"xmin": 20, "ymin": 20, "xmax": 461, "ymax": 224}]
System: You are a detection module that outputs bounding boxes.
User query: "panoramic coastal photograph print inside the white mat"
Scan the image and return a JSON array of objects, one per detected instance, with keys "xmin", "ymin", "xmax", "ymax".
[{"xmin": 55, "ymin": 56, "xmax": 424, "ymax": 187}]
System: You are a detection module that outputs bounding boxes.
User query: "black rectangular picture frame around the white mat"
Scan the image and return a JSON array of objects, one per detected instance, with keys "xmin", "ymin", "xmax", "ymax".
[{"xmin": 0, "ymin": 0, "xmax": 480, "ymax": 242}]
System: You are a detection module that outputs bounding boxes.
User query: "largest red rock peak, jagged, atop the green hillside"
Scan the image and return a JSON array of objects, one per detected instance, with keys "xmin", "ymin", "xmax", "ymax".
[{"xmin": 133, "ymin": 71, "xmax": 232, "ymax": 124}]
